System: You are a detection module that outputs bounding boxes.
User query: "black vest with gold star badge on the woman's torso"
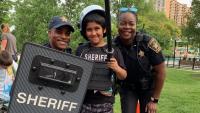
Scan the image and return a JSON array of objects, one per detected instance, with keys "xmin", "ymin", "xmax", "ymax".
[{"xmin": 115, "ymin": 33, "xmax": 154, "ymax": 90}]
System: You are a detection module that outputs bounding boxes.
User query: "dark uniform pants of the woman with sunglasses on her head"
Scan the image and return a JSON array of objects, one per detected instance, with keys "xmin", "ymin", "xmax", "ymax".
[{"xmin": 120, "ymin": 88, "xmax": 152, "ymax": 113}]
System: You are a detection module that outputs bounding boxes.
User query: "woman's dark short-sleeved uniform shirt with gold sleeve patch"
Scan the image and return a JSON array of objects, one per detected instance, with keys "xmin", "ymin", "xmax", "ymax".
[{"xmin": 114, "ymin": 36, "xmax": 164, "ymax": 84}]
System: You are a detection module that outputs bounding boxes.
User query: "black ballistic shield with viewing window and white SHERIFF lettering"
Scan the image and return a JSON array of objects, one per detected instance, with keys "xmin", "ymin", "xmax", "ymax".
[{"xmin": 8, "ymin": 43, "xmax": 93, "ymax": 113}]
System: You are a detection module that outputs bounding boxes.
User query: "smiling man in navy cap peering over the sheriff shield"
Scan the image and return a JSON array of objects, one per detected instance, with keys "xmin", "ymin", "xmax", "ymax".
[{"xmin": 44, "ymin": 16, "xmax": 74, "ymax": 54}]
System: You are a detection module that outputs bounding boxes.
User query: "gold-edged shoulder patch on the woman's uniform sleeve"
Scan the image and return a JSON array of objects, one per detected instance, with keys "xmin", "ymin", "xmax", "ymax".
[{"xmin": 148, "ymin": 38, "xmax": 161, "ymax": 53}]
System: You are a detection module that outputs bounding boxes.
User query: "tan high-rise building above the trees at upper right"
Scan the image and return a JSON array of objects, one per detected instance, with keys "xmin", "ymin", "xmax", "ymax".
[{"xmin": 155, "ymin": 0, "xmax": 191, "ymax": 26}]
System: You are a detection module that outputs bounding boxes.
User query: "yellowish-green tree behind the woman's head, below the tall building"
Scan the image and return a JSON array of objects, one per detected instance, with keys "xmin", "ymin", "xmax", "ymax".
[{"xmin": 111, "ymin": 0, "xmax": 181, "ymax": 49}]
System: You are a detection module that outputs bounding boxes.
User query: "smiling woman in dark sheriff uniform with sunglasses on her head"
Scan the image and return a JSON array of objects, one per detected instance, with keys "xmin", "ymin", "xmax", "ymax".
[{"xmin": 115, "ymin": 7, "xmax": 165, "ymax": 113}]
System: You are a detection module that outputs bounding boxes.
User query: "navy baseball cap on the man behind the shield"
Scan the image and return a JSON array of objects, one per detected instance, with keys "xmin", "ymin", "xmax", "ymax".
[{"xmin": 49, "ymin": 16, "xmax": 74, "ymax": 32}]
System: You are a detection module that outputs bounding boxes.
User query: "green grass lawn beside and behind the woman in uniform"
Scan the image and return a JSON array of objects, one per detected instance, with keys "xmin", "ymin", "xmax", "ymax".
[{"xmin": 114, "ymin": 68, "xmax": 200, "ymax": 113}]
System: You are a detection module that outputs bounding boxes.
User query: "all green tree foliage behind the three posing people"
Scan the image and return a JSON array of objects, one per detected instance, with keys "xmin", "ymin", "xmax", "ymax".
[{"xmin": 13, "ymin": 0, "xmax": 180, "ymax": 53}]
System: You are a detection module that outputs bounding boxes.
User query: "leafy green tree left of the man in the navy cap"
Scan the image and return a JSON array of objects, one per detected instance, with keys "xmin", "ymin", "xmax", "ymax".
[{"xmin": 13, "ymin": 0, "xmax": 63, "ymax": 49}]
